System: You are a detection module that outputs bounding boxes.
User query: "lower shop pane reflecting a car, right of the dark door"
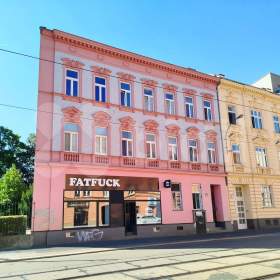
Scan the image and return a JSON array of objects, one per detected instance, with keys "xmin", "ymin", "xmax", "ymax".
[{"xmin": 136, "ymin": 200, "xmax": 161, "ymax": 225}]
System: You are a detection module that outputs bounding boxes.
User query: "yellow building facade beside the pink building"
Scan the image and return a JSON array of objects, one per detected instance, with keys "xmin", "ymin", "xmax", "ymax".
[{"xmin": 218, "ymin": 79, "xmax": 280, "ymax": 229}]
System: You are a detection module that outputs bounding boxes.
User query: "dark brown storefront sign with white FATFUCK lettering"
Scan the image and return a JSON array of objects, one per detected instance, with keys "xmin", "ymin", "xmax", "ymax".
[{"xmin": 65, "ymin": 174, "xmax": 159, "ymax": 191}]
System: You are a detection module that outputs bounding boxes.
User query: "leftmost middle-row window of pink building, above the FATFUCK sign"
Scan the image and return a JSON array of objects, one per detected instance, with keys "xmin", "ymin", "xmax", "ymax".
[{"xmin": 64, "ymin": 123, "xmax": 79, "ymax": 153}]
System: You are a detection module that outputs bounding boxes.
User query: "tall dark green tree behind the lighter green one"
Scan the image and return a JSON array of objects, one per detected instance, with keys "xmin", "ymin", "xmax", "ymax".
[{"xmin": 0, "ymin": 126, "xmax": 35, "ymax": 185}]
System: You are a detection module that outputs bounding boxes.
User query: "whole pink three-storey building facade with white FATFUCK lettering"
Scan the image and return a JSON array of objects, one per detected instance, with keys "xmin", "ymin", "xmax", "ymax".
[{"xmin": 32, "ymin": 28, "xmax": 231, "ymax": 244}]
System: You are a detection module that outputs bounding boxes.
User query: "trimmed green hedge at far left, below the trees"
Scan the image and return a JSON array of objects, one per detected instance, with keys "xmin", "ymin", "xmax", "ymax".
[{"xmin": 0, "ymin": 215, "xmax": 27, "ymax": 235}]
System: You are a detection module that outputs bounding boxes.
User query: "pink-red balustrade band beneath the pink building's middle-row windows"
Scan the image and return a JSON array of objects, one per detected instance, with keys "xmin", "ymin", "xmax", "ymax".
[{"xmin": 55, "ymin": 152, "xmax": 225, "ymax": 174}]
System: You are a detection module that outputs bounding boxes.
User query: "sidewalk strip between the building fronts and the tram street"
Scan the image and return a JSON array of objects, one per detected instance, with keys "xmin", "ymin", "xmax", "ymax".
[{"xmin": 0, "ymin": 230, "xmax": 279, "ymax": 263}]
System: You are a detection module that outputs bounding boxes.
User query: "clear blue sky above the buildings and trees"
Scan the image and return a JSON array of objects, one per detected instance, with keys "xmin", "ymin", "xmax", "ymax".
[{"xmin": 0, "ymin": 0, "xmax": 280, "ymax": 140}]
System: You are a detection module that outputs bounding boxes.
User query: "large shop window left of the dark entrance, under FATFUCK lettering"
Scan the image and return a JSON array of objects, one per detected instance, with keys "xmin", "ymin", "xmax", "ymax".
[{"xmin": 64, "ymin": 191, "xmax": 110, "ymax": 228}]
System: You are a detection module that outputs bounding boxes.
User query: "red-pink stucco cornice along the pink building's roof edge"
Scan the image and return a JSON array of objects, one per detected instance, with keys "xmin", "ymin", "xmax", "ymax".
[{"xmin": 41, "ymin": 28, "xmax": 220, "ymax": 85}]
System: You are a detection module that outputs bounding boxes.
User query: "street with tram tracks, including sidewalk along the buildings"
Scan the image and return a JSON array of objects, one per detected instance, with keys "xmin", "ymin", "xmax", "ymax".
[{"xmin": 0, "ymin": 232, "xmax": 280, "ymax": 280}]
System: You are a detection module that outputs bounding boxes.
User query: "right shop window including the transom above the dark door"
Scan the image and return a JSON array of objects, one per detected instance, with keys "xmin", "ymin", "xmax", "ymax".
[{"xmin": 124, "ymin": 191, "xmax": 161, "ymax": 225}]
